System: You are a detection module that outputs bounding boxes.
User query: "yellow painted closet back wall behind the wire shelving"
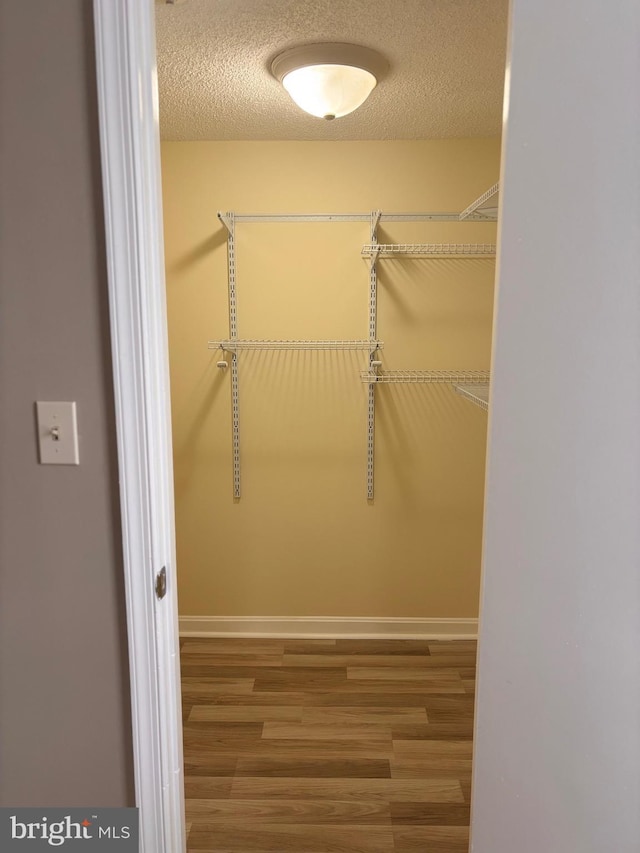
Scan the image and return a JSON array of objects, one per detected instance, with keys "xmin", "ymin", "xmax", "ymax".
[{"xmin": 162, "ymin": 139, "xmax": 499, "ymax": 618}]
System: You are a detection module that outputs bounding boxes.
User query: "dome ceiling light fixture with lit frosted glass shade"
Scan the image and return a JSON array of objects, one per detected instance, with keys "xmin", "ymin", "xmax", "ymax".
[{"xmin": 271, "ymin": 44, "xmax": 389, "ymax": 119}]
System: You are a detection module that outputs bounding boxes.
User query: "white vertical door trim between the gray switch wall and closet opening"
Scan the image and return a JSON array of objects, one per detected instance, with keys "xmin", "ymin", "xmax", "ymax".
[{"xmin": 93, "ymin": 0, "xmax": 185, "ymax": 853}]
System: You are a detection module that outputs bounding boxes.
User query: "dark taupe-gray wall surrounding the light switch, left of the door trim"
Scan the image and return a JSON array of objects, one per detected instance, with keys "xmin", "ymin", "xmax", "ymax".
[{"xmin": 0, "ymin": 0, "xmax": 134, "ymax": 806}]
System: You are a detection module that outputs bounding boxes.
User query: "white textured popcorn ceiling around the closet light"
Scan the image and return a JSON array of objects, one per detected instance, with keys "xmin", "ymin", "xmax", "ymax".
[{"xmin": 156, "ymin": 0, "xmax": 508, "ymax": 140}]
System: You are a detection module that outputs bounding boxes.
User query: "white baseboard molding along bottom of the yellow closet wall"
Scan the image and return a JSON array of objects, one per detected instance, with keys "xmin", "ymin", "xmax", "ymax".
[{"xmin": 180, "ymin": 616, "xmax": 478, "ymax": 640}]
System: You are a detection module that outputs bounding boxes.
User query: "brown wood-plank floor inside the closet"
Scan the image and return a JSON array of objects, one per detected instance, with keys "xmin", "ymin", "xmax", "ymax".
[{"xmin": 181, "ymin": 639, "xmax": 476, "ymax": 853}]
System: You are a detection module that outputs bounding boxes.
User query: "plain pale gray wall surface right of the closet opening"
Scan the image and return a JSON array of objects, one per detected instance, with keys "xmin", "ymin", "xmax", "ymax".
[{"xmin": 472, "ymin": 0, "xmax": 640, "ymax": 853}]
